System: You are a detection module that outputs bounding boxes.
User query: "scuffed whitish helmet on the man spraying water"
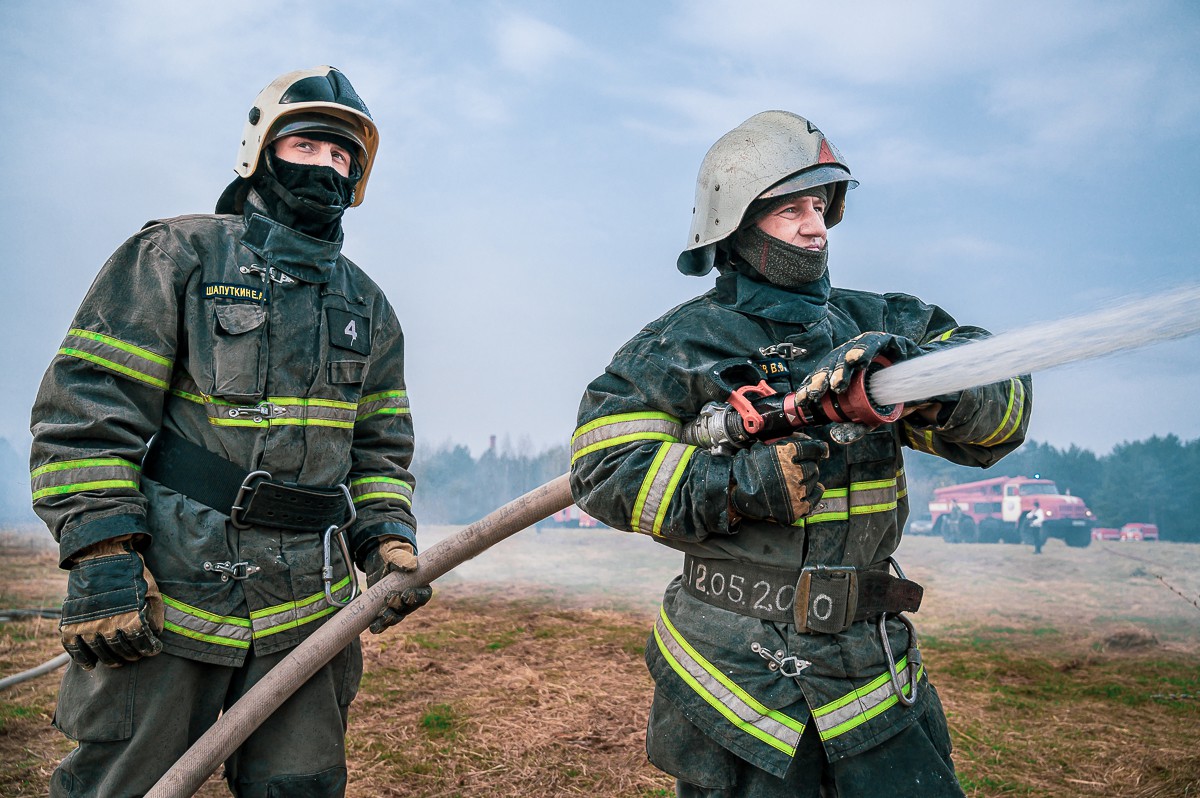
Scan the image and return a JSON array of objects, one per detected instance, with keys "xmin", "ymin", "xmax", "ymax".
[{"xmin": 677, "ymin": 110, "xmax": 858, "ymax": 275}]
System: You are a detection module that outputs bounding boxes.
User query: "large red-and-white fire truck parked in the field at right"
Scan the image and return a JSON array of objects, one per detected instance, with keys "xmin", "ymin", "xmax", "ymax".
[{"xmin": 929, "ymin": 476, "xmax": 1096, "ymax": 547}]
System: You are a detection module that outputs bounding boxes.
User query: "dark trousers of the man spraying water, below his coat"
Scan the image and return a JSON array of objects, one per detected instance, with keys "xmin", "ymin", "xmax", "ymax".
[{"xmin": 646, "ymin": 686, "xmax": 964, "ymax": 798}]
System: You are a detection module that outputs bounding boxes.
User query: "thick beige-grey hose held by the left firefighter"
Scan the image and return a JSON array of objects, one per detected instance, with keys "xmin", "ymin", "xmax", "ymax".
[{"xmin": 145, "ymin": 474, "xmax": 571, "ymax": 798}]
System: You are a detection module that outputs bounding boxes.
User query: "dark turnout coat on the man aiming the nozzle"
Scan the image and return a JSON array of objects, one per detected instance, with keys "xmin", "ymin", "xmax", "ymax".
[{"xmin": 571, "ymin": 266, "xmax": 1031, "ymax": 776}]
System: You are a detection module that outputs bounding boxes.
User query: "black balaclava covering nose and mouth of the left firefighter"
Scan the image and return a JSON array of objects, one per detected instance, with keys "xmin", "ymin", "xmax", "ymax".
[{"xmin": 251, "ymin": 132, "xmax": 361, "ymax": 241}]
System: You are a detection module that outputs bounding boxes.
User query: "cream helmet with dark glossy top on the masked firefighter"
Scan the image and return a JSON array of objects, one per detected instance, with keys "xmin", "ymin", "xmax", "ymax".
[{"xmin": 234, "ymin": 66, "xmax": 379, "ymax": 205}]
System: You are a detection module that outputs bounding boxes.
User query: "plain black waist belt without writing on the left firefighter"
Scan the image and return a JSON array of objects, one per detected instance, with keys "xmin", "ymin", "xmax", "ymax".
[{"xmin": 142, "ymin": 430, "xmax": 352, "ymax": 533}]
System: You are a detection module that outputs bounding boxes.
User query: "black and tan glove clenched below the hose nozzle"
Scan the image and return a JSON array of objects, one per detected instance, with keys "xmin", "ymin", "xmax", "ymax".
[{"xmin": 730, "ymin": 434, "xmax": 829, "ymax": 524}]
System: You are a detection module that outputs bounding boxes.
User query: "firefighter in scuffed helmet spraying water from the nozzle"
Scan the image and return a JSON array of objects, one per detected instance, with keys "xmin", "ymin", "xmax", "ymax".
[{"xmin": 571, "ymin": 112, "xmax": 1031, "ymax": 797}]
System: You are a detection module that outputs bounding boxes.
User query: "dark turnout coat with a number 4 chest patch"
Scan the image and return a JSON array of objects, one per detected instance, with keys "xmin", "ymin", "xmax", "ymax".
[{"xmin": 31, "ymin": 193, "xmax": 415, "ymax": 666}]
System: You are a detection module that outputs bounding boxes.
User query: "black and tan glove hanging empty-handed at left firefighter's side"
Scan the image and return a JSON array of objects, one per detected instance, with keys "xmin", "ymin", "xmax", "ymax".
[{"xmin": 59, "ymin": 535, "xmax": 163, "ymax": 671}]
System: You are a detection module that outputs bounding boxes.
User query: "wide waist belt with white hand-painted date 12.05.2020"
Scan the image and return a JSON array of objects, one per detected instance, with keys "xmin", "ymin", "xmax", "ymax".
[{"xmin": 683, "ymin": 554, "xmax": 925, "ymax": 635}]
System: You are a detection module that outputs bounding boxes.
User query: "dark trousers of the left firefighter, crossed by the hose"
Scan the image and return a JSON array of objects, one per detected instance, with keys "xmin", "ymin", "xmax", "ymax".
[{"xmin": 50, "ymin": 640, "xmax": 362, "ymax": 798}]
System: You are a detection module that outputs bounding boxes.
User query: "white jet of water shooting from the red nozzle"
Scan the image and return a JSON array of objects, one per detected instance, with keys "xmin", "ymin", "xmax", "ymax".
[{"xmin": 866, "ymin": 286, "xmax": 1200, "ymax": 406}]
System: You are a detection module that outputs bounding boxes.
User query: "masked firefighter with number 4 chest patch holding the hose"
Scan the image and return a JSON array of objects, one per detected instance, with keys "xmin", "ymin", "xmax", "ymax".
[{"xmin": 31, "ymin": 66, "xmax": 431, "ymax": 797}]
